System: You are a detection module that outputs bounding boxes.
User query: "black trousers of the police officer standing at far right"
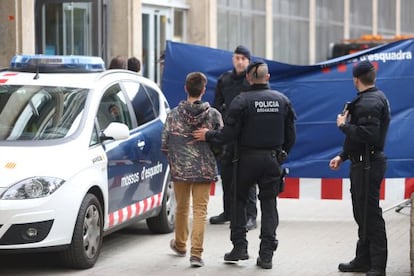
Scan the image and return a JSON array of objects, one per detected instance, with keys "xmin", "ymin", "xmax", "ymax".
[{"xmin": 350, "ymin": 155, "xmax": 388, "ymax": 271}]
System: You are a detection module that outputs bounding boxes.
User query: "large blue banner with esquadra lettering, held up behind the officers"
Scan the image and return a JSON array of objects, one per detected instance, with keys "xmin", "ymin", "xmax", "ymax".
[{"xmin": 162, "ymin": 39, "xmax": 414, "ymax": 178}]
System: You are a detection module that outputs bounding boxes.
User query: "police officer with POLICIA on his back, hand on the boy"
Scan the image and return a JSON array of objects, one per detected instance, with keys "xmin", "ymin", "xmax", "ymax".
[{"xmin": 193, "ymin": 61, "xmax": 296, "ymax": 269}]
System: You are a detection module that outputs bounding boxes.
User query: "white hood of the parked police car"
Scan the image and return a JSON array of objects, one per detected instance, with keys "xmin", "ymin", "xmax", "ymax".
[{"xmin": 0, "ymin": 145, "xmax": 90, "ymax": 191}]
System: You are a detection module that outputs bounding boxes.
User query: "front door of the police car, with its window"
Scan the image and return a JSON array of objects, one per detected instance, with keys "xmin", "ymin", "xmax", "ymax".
[{"xmin": 97, "ymin": 83, "xmax": 150, "ymax": 216}]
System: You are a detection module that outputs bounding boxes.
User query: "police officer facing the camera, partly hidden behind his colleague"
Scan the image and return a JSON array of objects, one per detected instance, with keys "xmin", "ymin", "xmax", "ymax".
[{"xmin": 210, "ymin": 45, "xmax": 257, "ymax": 230}]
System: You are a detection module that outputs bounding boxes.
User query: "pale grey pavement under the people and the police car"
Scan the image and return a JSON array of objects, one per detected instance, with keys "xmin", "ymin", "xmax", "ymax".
[{"xmin": 0, "ymin": 191, "xmax": 411, "ymax": 276}]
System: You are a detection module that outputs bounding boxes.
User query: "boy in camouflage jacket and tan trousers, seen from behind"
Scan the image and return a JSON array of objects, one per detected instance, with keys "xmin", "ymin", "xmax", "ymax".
[{"xmin": 162, "ymin": 72, "xmax": 223, "ymax": 267}]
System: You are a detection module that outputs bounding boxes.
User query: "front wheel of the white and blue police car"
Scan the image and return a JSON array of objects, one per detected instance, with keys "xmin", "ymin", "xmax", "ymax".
[{"xmin": 61, "ymin": 194, "xmax": 103, "ymax": 269}]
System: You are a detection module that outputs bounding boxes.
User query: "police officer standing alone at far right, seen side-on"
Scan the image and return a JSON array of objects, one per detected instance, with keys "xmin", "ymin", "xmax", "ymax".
[{"xmin": 329, "ymin": 61, "xmax": 390, "ymax": 276}]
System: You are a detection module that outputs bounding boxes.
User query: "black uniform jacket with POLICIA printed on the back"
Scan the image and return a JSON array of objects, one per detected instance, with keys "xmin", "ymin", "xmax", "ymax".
[{"xmin": 206, "ymin": 84, "xmax": 296, "ymax": 152}]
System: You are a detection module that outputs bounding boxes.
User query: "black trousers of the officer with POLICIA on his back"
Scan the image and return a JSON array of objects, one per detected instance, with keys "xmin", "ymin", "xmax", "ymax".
[{"xmin": 230, "ymin": 150, "xmax": 281, "ymax": 259}]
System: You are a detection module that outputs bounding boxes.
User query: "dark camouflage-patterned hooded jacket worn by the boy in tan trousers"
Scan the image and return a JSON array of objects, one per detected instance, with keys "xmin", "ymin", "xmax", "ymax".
[{"xmin": 161, "ymin": 101, "xmax": 223, "ymax": 182}]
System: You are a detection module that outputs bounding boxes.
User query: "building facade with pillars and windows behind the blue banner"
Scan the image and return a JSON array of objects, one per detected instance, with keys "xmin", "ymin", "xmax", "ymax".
[{"xmin": 0, "ymin": 0, "xmax": 414, "ymax": 83}]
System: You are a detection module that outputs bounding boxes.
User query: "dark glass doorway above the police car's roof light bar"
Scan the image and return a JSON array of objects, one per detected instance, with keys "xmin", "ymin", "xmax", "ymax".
[{"xmin": 35, "ymin": 0, "xmax": 104, "ymax": 57}]
